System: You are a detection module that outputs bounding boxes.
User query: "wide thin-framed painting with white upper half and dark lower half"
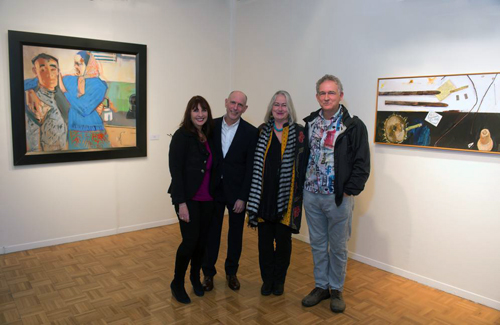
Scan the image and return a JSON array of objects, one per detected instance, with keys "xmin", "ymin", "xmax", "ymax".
[{"xmin": 375, "ymin": 73, "xmax": 500, "ymax": 154}]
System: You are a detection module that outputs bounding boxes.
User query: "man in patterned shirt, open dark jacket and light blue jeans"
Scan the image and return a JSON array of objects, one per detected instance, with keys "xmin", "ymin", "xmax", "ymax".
[{"xmin": 302, "ymin": 75, "xmax": 370, "ymax": 313}]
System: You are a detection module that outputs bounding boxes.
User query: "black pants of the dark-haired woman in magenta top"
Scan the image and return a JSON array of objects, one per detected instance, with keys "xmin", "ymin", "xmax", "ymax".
[{"xmin": 174, "ymin": 200, "xmax": 214, "ymax": 283}]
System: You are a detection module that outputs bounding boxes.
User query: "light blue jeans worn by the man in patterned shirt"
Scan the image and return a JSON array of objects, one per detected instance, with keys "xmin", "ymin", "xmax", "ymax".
[{"xmin": 304, "ymin": 190, "xmax": 354, "ymax": 291}]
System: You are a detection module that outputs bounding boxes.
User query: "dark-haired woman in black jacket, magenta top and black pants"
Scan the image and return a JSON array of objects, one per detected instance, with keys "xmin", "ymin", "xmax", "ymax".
[{"xmin": 168, "ymin": 96, "xmax": 214, "ymax": 304}]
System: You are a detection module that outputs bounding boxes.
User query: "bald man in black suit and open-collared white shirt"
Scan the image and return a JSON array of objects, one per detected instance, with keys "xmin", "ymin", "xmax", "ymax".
[{"xmin": 202, "ymin": 91, "xmax": 257, "ymax": 291}]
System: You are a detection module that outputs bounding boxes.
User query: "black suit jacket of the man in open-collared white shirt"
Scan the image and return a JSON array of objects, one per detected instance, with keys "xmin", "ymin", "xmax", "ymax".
[{"xmin": 212, "ymin": 117, "xmax": 258, "ymax": 205}]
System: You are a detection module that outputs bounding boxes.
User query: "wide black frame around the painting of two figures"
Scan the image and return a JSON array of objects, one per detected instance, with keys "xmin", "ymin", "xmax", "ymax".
[{"xmin": 8, "ymin": 30, "xmax": 147, "ymax": 166}]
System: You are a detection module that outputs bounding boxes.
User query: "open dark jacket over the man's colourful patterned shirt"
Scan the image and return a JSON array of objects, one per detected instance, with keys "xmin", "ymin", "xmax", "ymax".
[{"xmin": 304, "ymin": 105, "xmax": 370, "ymax": 206}]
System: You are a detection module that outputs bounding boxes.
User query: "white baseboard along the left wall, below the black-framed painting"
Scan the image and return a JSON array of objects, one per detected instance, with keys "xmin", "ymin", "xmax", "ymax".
[{"xmin": 0, "ymin": 218, "xmax": 178, "ymax": 255}]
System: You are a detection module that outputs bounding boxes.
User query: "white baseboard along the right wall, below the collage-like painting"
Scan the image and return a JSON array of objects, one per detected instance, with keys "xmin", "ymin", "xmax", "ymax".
[{"xmin": 349, "ymin": 252, "xmax": 500, "ymax": 310}]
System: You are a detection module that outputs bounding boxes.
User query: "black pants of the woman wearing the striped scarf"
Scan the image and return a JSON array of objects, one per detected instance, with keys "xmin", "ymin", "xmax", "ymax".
[{"xmin": 258, "ymin": 221, "xmax": 292, "ymax": 283}]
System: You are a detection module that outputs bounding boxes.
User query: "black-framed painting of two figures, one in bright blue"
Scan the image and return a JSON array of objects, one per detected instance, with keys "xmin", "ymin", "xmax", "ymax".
[{"xmin": 9, "ymin": 31, "xmax": 147, "ymax": 165}]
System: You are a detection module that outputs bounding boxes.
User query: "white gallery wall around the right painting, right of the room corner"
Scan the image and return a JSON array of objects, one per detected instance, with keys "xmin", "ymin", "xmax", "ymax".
[{"xmin": 232, "ymin": 0, "xmax": 500, "ymax": 309}]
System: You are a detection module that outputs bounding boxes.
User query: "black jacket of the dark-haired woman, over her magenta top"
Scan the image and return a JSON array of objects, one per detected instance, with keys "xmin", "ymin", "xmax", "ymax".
[{"xmin": 168, "ymin": 127, "xmax": 213, "ymax": 204}]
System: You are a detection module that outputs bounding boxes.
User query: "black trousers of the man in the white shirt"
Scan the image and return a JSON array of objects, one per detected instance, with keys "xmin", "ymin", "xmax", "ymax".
[{"xmin": 203, "ymin": 202, "xmax": 245, "ymax": 276}]
